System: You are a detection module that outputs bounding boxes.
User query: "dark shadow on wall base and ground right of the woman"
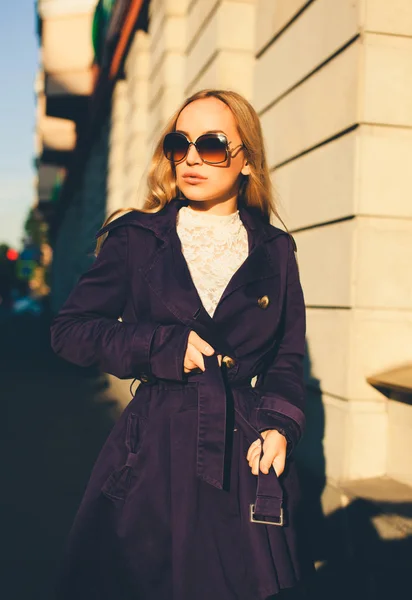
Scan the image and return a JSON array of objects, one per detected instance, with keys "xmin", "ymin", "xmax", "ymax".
[{"xmin": 296, "ymin": 340, "xmax": 412, "ymax": 600}]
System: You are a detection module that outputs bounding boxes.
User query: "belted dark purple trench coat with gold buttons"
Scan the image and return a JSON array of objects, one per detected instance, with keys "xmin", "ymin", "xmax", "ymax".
[{"xmin": 51, "ymin": 199, "xmax": 312, "ymax": 600}]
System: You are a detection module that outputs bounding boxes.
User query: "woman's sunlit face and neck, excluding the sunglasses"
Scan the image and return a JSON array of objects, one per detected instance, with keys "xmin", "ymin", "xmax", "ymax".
[{"xmin": 175, "ymin": 98, "xmax": 250, "ymax": 208}]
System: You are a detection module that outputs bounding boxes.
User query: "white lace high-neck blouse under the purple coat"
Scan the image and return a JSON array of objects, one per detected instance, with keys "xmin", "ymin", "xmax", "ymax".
[{"xmin": 176, "ymin": 206, "xmax": 248, "ymax": 316}]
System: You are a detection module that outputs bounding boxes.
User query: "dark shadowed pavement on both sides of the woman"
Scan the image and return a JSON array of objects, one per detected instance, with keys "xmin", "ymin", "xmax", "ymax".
[{"xmin": 0, "ymin": 314, "xmax": 412, "ymax": 600}]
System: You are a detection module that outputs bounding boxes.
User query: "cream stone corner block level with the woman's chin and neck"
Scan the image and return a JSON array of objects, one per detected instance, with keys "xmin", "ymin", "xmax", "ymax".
[{"xmin": 272, "ymin": 125, "xmax": 412, "ymax": 230}]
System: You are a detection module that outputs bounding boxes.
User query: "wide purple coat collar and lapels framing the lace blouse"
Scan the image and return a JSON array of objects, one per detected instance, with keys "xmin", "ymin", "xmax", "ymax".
[{"xmin": 96, "ymin": 198, "xmax": 285, "ymax": 354}]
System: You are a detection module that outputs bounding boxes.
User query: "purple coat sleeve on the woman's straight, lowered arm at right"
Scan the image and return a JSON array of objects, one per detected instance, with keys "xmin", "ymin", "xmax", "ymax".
[{"xmin": 255, "ymin": 238, "xmax": 306, "ymax": 455}]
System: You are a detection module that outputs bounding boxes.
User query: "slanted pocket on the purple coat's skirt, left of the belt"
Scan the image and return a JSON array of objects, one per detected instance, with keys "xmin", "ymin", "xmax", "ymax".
[{"xmin": 102, "ymin": 412, "xmax": 147, "ymax": 500}]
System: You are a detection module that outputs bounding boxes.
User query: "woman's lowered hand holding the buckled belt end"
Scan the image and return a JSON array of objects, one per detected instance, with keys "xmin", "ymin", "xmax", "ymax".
[{"xmin": 246, "ymin": 429, "xmax": 287, "ymax": 477}]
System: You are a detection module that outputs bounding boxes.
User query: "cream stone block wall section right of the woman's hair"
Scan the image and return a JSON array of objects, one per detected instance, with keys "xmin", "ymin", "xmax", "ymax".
[{"xmin": 253, "ymin": 0, "xmax": 412, "ymax": 484}]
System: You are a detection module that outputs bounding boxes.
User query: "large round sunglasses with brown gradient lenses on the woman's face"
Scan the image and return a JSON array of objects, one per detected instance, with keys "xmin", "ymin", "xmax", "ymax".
[{"xmin": 163, "ymin": 132, "xmax": 244, "ymax": 165}]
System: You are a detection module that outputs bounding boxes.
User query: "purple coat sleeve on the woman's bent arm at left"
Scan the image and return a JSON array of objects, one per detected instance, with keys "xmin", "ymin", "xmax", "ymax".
[{"xmin": 51, "ymin": 226, "xmax": 190, "ymax": 381}]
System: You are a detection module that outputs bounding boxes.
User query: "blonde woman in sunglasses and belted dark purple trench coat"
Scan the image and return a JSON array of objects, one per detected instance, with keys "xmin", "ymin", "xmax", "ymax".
[{"xmin": 51, "ymin": 90, "xmax": 312, "ymax": 600}]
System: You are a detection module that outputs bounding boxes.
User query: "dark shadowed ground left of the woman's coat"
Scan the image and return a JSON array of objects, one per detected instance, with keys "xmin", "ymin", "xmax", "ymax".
[{"xmin": 0, "ymin": 316, "xmax": 118, "ymax": 600}]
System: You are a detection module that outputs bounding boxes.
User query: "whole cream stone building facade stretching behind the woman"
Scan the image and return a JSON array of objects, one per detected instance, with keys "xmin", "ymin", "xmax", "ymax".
[{"xmin": 34, "ymin": 0, "xmax": 412, "ymax": 544}]
